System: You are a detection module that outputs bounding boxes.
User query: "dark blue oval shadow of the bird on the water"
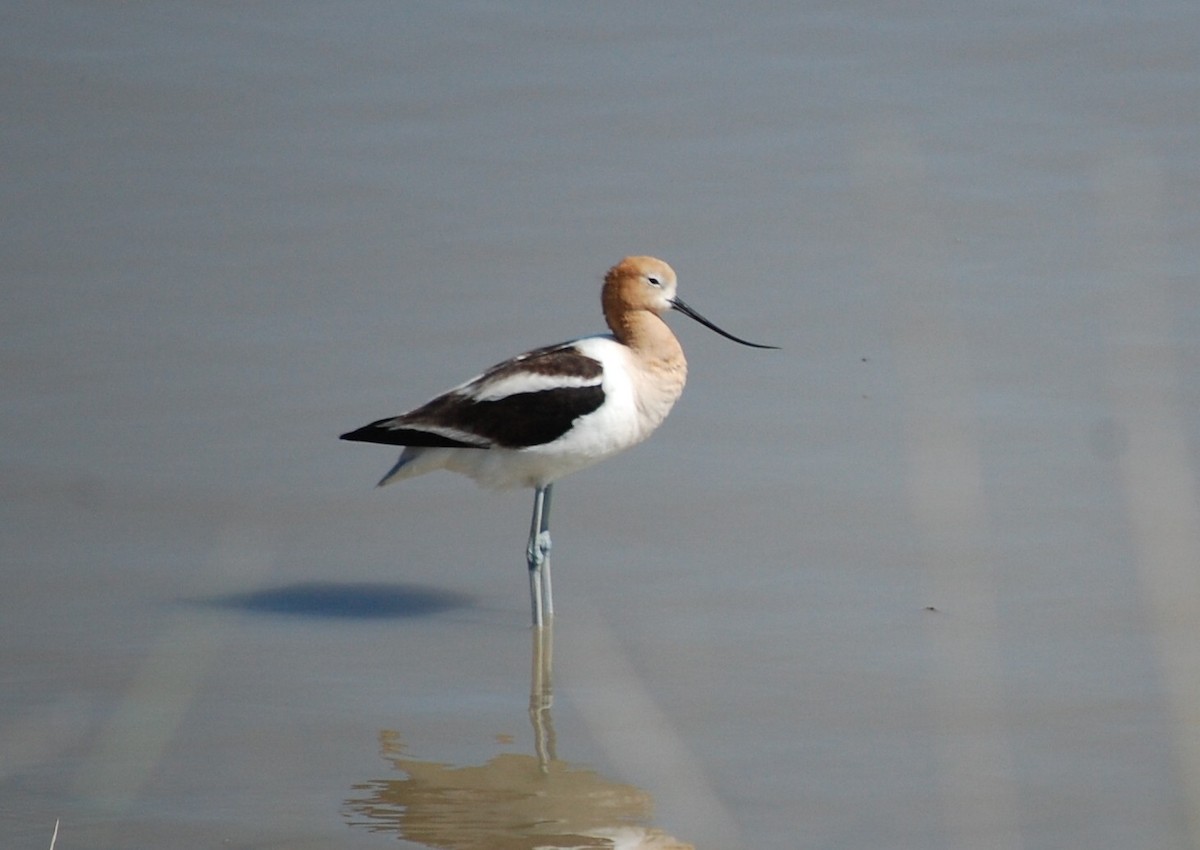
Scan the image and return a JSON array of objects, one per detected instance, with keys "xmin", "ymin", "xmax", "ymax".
[{"xmin": 197, "ymin": 581, "xmax": 474, "ymax": 619}]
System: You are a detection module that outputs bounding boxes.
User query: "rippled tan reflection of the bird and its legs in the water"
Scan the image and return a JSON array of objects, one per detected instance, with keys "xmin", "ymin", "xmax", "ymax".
[{"xmin": 347, "ymin": 628, "xmax": 692, "ymax": 850}]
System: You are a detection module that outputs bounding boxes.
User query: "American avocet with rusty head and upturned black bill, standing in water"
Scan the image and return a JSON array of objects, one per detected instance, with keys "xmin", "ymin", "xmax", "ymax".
[{"xmin": 342, "ymin": 257, "xmax": 775, "ymax": 625}]
